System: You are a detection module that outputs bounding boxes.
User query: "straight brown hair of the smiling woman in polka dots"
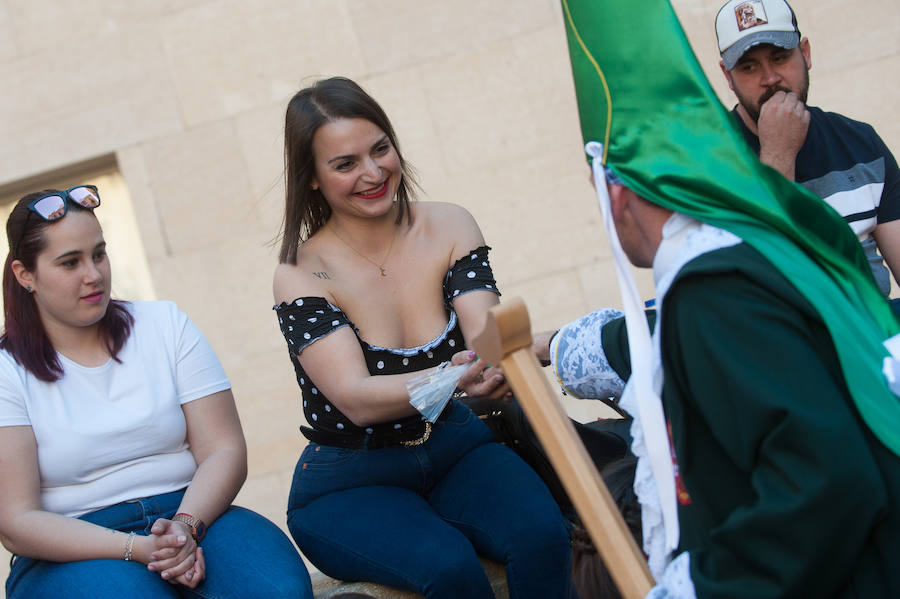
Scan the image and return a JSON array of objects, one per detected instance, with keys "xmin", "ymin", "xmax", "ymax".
[{"xmin": 279, "ymin": 77, "xmax": 418, "ymax": 264}]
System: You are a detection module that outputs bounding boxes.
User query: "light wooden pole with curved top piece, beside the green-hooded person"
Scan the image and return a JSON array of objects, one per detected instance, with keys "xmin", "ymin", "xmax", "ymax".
[{"xmin": 472, "ymin": 298, "xmax": 653, "ymax": 599}]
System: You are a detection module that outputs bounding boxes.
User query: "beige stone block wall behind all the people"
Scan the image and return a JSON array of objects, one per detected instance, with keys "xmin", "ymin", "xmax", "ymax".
[{"xmin": 0, "ymin": 0, "xmax": 900, "ymax": 574}]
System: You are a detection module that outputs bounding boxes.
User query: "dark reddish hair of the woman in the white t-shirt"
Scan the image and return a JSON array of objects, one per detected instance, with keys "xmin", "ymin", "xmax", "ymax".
[{"xmin": 0, "ymin": 189, "xmax": 134, "ymax": 383}]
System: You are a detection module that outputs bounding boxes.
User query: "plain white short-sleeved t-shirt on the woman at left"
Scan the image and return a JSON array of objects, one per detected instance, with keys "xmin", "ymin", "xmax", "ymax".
[{"xmin": 0, "ymin": 302, "xmax": 231, "ymax": 516}]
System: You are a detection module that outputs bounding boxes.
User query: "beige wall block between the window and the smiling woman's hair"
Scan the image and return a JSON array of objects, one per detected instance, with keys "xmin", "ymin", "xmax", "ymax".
[{"xmin": 135, "ymin": 121, "xmax": 271, "ymax": 255}]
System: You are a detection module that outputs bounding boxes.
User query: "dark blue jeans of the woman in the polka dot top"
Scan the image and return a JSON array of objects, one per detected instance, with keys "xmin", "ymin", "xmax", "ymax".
[{"xmin": 288, "ymin": 402, "xmax": 571, "ymax": 599}]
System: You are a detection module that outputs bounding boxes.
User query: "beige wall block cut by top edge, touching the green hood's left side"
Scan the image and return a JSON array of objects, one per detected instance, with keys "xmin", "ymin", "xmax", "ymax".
[{"xmin": 348, "ymin": 0, "xmax": 558, "ymax": 73}]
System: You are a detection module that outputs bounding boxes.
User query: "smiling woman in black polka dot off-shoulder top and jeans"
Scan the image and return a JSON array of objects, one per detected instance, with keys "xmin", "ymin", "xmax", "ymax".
[{"xmin": 273, "ymin": 78, "xmax": 570, "ymax": 599}]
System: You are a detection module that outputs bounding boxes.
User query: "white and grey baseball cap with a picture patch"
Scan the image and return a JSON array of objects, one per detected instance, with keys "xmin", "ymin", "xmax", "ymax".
[{"xmin": 716, "ymin": 0, "xmax": 800, "ymax": 71}]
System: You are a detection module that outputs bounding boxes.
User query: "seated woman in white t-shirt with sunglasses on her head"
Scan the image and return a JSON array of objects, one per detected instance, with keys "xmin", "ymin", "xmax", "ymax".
[{"xmin": 0, "ymin": 185, "xmax": 312, "ymax": 599}]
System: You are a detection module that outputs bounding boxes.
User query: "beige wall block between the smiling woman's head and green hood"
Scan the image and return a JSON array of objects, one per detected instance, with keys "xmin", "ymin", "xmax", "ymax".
[{"xmin": 423, "ymin": 26, "xmax": 581, "ymax": 178}]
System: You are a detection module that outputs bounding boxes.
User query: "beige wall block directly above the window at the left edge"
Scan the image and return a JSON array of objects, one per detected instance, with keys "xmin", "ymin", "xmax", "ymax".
[{"xmin": 0, "ymin": 26, "xmax": 180, "ymax": 180}]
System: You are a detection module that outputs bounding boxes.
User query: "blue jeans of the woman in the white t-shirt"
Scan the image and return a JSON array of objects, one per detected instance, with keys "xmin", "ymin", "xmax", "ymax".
[{"xmin": 6, "ymin": 491, "xmax": 313, "ymax": 599}]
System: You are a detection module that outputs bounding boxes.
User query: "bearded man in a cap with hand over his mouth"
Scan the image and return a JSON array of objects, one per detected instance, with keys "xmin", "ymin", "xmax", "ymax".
[{"xmin": 716, "ymin": 0, "xmax": 900, "ymax": 296}]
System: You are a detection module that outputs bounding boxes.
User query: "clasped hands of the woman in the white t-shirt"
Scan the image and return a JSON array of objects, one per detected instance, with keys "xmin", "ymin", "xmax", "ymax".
[{"xmin": 145, "ymin": 518, "xmax": 206, "ymax": 589}]
